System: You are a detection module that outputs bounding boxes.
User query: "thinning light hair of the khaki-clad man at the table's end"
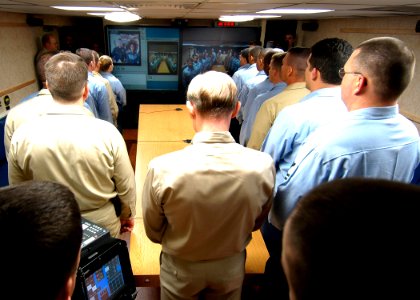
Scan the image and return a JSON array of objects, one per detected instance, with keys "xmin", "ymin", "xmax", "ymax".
[{"xmin": 187, "ymin": 71, "xmax": 237, "ymax": 117}]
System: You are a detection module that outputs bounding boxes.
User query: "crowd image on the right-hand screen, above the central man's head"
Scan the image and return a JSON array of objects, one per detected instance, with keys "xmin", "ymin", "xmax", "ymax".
[{"xmin": 182, "ymin": 45, "xmax": 243, "ymax": 88}]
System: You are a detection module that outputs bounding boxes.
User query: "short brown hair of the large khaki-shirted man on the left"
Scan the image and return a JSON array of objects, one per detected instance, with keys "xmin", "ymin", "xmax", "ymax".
[{"xmin": 45, "ymin": 52, "xmax": 88, "ymax": 102}]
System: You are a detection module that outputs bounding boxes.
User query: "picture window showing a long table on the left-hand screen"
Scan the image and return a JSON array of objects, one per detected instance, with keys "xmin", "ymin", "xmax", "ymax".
[{"xmin": 147, "ymin": 42, "xmax": 178, "ymax": 75}]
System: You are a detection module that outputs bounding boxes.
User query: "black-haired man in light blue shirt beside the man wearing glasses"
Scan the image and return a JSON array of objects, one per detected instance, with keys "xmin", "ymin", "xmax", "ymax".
[{"xmin": 261, "ymin": 38, "xmax": 353, "ymax": 188}]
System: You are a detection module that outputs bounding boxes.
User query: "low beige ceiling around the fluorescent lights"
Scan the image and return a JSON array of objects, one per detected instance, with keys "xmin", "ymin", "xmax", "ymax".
[{"xmin": 0, "ymin": 0, "xmax": 420, "ymax": 20}]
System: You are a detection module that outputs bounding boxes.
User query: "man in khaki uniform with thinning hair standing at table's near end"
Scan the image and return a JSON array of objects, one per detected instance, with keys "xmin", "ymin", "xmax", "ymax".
[{"xmin": 142, "ymin": 71, "xmax": 275, "ymax": 299}]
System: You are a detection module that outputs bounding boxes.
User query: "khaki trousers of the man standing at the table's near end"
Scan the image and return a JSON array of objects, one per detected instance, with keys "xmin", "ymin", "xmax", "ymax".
[{"xmin": 160, "ymin": 251, "xmax": 246, "ymax": 300}]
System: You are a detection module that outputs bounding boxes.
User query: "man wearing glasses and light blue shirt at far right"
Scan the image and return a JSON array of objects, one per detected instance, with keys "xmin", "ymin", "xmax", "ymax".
[{"xmin": 270, "ymin": 37, "xmax": 420, "ymax": 298}]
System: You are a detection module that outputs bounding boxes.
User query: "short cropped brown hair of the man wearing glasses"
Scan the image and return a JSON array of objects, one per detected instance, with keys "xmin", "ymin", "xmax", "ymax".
[{"xmin": 354, "ymin": 37, "xmax": 416, "ymax": 99}]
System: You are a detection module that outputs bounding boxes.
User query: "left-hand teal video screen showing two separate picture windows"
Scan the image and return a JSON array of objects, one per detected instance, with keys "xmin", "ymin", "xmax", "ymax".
[{"xmin": 106, "ymin": 26, "xmax": 180, "ymax": 90}]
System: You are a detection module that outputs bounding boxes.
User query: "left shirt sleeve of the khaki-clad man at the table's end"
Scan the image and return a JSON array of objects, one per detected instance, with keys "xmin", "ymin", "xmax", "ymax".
[{"xmin": 142, "ymin": 165, "xmax": 167, "ymax": 243}]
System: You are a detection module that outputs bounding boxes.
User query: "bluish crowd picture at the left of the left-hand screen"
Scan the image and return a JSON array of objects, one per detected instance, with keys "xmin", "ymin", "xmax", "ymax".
[{"xmin": 110, "ymin": 33, "xmax": 141, "ymax": 66}]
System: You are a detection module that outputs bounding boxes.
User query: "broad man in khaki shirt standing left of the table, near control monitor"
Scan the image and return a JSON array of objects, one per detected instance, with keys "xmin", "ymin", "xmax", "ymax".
[{"xmin": 9, "ymin": 53, "xmax": 136, "ymax": 237}]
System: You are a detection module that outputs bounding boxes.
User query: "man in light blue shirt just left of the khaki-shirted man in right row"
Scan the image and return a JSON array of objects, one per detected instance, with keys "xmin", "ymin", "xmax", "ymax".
[{"xmin": 239, "ymin": 53, "xmax": 287, "ymax": 146}]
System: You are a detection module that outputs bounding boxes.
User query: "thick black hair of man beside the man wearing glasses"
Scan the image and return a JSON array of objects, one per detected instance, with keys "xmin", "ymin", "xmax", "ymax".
[{"xmin": 309, "ymin": 38, "xmax": 353, "ymax": 85}]
